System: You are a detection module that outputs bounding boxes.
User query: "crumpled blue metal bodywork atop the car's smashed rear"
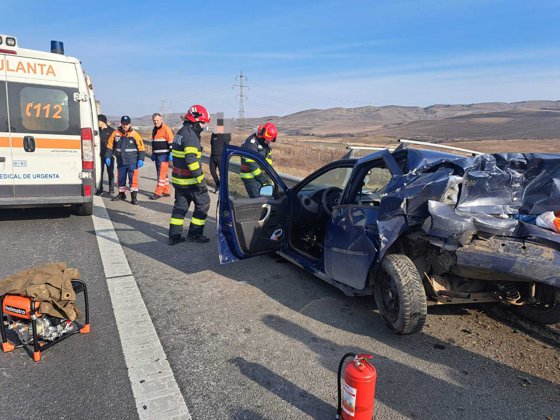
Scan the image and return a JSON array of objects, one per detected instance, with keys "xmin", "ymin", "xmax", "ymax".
[{"xmin": 378, "ymin": 149, "xmax": 560, "ymax": 260}]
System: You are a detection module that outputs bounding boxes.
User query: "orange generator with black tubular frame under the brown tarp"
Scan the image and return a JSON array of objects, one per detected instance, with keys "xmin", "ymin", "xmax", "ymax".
[{"xmin": 0, "ymin": 280, "xmax": 90, "ymax": 362}]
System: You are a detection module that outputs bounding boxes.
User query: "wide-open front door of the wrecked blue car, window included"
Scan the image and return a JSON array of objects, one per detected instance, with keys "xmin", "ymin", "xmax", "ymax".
[{"xmin": 216, "ymin": 145, "xmax": 289, "ymax": 264}]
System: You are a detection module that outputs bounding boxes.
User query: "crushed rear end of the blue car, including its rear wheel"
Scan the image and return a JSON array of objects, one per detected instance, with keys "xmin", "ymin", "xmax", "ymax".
[{"xmin": 374, "ymin": 148, "xmax": 560, "ymax": 334}]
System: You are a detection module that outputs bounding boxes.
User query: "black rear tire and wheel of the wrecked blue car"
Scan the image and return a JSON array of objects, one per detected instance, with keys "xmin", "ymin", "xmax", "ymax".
[{"xmin": 373, "ymin": 254, "xmax": 428, "ymax": 335}]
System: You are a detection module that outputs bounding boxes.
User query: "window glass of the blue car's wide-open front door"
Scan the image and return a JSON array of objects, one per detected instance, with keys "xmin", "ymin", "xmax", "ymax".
[{"xmin": 228, "ymin": 154, "xmax": 276, "ymax": 199}]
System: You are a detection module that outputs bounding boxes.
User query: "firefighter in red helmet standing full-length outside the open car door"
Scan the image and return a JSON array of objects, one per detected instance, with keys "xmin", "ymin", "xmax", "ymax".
[{"xmin": 169, "ymin": 105, "xmax": 210, "ymax": 245}]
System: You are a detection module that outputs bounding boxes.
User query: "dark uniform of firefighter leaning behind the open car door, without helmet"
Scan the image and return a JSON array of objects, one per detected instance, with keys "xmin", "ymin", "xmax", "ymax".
[{"xmin": 239, "ymin": 134, "xmax": 272, "ymax": 198}]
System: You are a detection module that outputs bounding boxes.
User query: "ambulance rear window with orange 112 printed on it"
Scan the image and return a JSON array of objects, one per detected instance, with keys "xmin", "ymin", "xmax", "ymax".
[{"xmin": 8, "ymin": 83, "xmax": 80, "ymax": 134}]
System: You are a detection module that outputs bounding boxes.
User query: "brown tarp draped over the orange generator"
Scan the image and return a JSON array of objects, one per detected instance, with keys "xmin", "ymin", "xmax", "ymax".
[{"xmin": 0, "ymin": 262, "xmax": 82, "ymax": 321}]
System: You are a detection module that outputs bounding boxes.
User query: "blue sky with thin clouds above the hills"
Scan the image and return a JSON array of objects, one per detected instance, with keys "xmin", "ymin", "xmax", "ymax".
[{"xmin": 0, "ymin": 0, "xmax": 560, "ymax": 117}]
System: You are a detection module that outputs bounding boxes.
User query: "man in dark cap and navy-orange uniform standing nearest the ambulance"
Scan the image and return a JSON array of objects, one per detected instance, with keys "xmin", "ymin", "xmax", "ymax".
[{"xmin": 105, "ymin": 115, "xmax": 146, "ymax": 204}]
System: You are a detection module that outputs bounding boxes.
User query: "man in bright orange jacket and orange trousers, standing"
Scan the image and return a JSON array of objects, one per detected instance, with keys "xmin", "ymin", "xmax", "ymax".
[{"xmin": 150, "ymin": 112, "xmax": 173, "ymax": 200}]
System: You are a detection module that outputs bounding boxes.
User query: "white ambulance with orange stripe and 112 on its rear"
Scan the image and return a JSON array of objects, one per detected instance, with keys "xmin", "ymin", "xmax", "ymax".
[{"xmin": 0, "ymin": 35, "xmax": 101, "ymax": 215}]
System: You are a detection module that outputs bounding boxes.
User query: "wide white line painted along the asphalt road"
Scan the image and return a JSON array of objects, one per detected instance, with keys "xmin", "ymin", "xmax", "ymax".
[{"xmin": 93, "ymin": 197, "xmax": 191, "ymax": 419}]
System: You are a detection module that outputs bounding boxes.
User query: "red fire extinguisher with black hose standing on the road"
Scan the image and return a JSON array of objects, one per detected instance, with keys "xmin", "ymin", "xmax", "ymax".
[{"xmin": 336, "ymin": 353, "xmax": 377, "ymax": 420}]
